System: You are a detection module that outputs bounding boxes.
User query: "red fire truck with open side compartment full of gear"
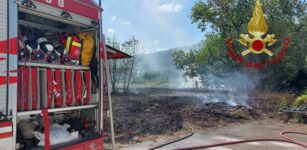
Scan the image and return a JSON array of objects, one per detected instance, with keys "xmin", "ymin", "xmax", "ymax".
[{"xmin": 0, "ymin": 0, "xmax": 129, "ymax": 150}]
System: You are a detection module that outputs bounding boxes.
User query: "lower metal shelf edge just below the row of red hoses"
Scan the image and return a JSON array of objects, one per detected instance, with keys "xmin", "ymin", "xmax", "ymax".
[{"xmin": 17, "ymin": 105, "xmax": 97, "ymax": 116}]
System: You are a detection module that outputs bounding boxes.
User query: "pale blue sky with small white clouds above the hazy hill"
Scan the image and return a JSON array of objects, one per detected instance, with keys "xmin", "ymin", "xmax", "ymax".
[{"xmin": 102, "ymin": 0, "xmax": 204, "ymax": 53}]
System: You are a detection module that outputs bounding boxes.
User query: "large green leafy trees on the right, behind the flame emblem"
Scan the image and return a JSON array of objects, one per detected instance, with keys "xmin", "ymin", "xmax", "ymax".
[{"xmin": 173, "ymin": 0, "xmax": 307, "ymax": 91}]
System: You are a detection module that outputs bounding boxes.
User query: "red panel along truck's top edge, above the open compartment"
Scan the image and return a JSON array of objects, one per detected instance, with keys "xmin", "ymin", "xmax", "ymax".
[{"xmin": 36, "ymin": 0, "xmax": 102, "ymax": 20}]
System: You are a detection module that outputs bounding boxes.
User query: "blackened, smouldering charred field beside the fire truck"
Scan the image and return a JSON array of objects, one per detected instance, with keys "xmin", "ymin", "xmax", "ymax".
[{"xmin": 105, "ymin": 88, "xmax": 293, "ymax": 144}]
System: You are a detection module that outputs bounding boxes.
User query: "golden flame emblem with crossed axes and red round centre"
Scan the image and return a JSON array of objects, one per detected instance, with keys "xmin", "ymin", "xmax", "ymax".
[{"xmin": 239, "ymin": 0, "xmax": 276, "ymax": 56}]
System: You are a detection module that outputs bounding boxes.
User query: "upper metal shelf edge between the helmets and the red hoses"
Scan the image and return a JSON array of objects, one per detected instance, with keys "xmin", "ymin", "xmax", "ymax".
[{"xmin": 18, "ymin": 62, "xmax": 90, "ymax": 70}]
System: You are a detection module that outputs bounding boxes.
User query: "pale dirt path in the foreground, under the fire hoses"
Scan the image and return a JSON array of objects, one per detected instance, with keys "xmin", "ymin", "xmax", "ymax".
[{"xmin": 123, "ymin": 119, "xmax": 307, "ymax": 150}]
